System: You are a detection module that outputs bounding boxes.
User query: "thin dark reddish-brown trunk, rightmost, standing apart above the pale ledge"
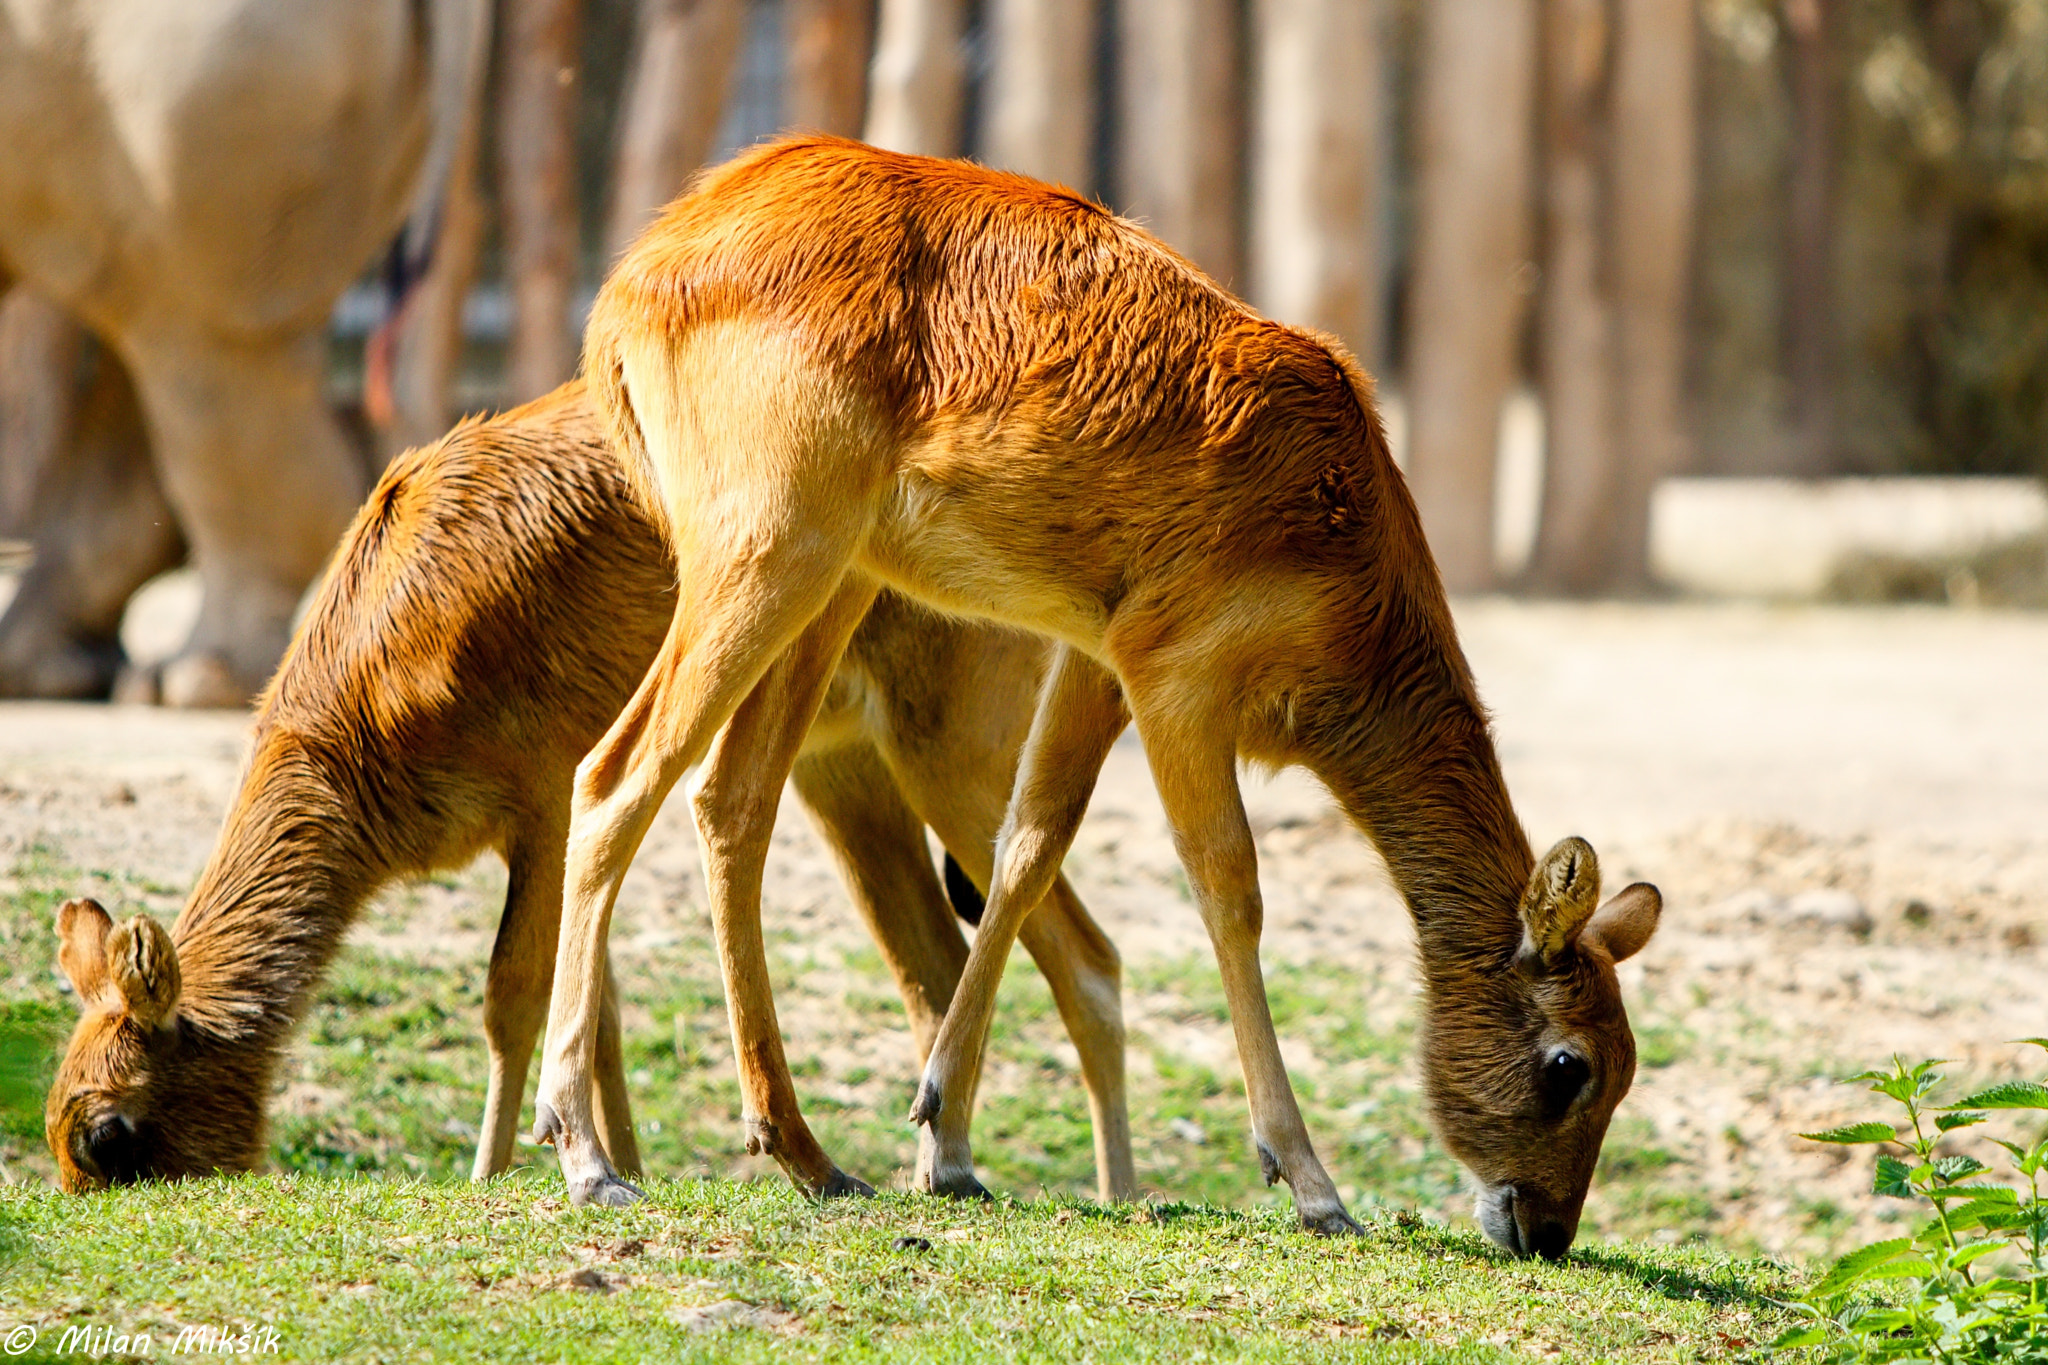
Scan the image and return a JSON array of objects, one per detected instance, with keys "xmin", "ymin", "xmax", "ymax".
[{"xmin": 1784, "ymin": 0, "xmax": 1841, "ymax": 475}]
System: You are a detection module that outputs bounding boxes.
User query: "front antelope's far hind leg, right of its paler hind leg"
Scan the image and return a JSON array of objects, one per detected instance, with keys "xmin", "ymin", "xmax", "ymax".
[{"xmin": 692, "ymin": 575, "xmax": 874, "ymax": 1197}]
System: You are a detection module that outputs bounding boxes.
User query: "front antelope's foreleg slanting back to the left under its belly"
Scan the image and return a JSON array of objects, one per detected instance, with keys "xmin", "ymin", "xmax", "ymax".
[{"xmin": 909, "ymin": 647, "xmax": 1128, "ymax": 1195}]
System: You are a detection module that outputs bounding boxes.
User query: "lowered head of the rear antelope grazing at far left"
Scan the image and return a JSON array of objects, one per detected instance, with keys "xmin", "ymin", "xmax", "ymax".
[{"xmin": 43, "ymin": 900, "xmax": 262, "ymax": 1193}]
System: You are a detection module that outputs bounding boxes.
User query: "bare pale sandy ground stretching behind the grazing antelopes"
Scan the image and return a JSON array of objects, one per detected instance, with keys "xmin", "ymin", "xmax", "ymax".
[{"xmin": 0, "ymin": 581, "xmax": 2048, "ymax": 1250}]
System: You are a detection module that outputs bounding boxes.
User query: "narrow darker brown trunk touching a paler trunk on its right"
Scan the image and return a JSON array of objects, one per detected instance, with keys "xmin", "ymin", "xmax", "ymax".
[{"xmin": 1528, "ymin": 0, "xmax": 1620, "ymax": 593}]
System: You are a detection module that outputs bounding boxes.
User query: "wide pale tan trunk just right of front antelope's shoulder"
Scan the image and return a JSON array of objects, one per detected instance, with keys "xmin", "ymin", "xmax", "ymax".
[{"xmin": 1407, "ymin": 0, "xmax": 1536, "ymax": 591}]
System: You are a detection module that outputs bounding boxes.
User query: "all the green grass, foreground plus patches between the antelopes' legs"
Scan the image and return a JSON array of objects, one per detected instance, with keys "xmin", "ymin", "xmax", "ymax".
[{"xmin": 0, "ymin": 851, "xmax": 1798, "ymax": 1363}]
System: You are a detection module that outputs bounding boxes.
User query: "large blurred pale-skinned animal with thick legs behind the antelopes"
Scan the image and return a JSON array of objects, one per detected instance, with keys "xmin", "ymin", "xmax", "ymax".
[{"xmin": 0, "ymin": 0, "xmax": 489, "ymax": 706}]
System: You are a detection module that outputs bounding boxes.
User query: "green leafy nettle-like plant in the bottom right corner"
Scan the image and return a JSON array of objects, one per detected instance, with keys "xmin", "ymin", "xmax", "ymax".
[{"xmin": 1774, "ymin": 1038, "xmax": 2048, "ymax": 1365}]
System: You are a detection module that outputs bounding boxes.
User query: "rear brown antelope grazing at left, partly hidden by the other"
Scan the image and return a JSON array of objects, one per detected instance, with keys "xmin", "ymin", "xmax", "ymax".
[{"xmin": 47, "ymin": 383, "xmax": 1133, "ymax": 1197}]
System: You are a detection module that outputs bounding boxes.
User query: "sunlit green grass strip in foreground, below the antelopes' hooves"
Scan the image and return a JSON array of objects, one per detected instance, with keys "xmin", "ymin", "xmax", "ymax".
[{"xmin": 0, "ymin": 1175, "xmax": 1788, "ymax": 1365}]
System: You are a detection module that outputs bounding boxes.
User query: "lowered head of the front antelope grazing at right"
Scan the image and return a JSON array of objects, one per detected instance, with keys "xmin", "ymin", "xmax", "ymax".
[{"xmin": 1423, "ymin": 839, "xmax": 1663, "ymax": 1261}]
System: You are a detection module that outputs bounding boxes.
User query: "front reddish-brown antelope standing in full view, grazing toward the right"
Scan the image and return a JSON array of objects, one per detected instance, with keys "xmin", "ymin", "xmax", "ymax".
[{"xmin": 537, "ymin": 137, "xmax": 1659, "ymax": 1257}]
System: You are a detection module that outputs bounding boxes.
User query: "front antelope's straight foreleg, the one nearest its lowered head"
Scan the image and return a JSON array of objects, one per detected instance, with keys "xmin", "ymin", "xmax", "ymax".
[{"xmin": 1139, "ymin": 708, "xmax": 1360, "ymax": 1234}]
